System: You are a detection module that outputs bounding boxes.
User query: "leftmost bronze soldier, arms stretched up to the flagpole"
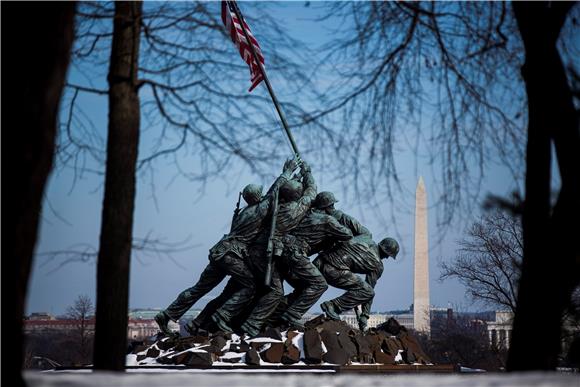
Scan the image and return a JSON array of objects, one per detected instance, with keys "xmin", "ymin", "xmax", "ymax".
[{"xmin": 155, "ymin": 160, "xmax": 297, "ymax": 335}]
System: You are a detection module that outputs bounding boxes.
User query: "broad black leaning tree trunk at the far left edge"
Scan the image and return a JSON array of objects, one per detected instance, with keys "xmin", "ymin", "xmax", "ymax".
[{"xmin": 2, "ymin": 2, "xmax": 76, "ymax": 385}]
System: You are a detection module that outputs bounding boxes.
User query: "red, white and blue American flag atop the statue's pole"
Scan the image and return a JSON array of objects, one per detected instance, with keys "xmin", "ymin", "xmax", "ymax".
[{"xmin": 222, "ymin": 1, "xmax": 264, "ymax": 91}]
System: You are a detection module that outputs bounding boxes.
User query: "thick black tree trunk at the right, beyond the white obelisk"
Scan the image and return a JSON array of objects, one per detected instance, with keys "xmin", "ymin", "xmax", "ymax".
[{"xmin": 507, "ymin": 2, "xmax": 580, "ymax": 371}]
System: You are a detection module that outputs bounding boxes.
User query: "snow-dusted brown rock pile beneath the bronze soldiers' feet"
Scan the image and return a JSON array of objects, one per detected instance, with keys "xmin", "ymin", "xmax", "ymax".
[{"xmin": 127, "ymin": 315, "xmax": 431, "ymax": 367}]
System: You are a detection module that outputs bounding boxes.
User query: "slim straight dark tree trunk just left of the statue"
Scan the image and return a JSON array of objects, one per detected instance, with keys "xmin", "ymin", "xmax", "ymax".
[{"xmin": 93, "ymin": 2, "xmax": 142, "ymax": 371}]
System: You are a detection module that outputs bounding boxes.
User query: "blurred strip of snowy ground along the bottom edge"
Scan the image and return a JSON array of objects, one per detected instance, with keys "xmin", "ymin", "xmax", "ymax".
[{"xmin": 24, "ymin": 370, "xmax": 580, "ymax": 387}]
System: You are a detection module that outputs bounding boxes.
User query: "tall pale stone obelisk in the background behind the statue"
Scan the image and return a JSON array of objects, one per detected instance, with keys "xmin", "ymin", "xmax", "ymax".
[{"xmin": 413, "ymin": 176, "xmax": 431, "ymax": 334}]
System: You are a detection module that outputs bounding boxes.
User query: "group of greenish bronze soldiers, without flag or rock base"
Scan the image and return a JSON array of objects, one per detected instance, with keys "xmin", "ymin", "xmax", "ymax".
[{"xmin": 155, "ymin": 170, "xmax": 399, "ymax": 336}]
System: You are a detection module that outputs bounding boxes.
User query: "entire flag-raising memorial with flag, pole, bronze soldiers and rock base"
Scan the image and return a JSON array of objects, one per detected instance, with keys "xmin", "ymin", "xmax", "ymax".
[{"xmin": 128, "ymin": 1, "xmax": 446, "ymax": 372}]
